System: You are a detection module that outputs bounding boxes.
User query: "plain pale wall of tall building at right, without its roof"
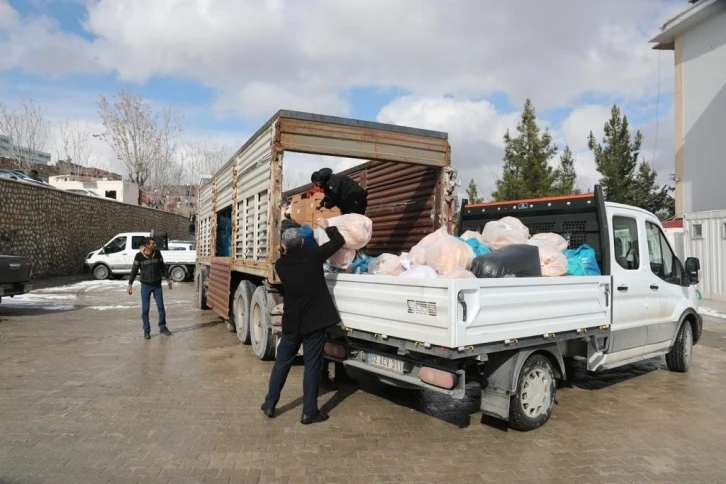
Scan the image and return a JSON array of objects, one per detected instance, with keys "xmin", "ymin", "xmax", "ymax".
[{"xmin": 676, "ymin": 10, "xmax": 726, "ymax": 213}]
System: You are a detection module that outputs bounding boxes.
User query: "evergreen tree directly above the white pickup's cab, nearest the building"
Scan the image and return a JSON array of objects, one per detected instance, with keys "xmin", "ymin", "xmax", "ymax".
[{"xmin": 587, "ymin": 106, "xmax": 675, "ymax": 217}]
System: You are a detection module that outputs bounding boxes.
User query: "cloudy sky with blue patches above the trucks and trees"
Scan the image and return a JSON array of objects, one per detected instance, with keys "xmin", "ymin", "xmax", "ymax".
[{"xmin": 0, "ymin": 0, "xmax": 688, "ymax": 199}]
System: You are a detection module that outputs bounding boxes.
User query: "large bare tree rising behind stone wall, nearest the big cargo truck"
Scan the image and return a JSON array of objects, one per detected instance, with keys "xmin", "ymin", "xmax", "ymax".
[{"xmin": 98, "ymin": 89, "xmax": 182, "ymax": 203}]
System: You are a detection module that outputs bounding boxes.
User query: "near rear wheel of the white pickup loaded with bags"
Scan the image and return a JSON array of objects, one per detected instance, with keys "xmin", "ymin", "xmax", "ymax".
[{"xmin": 509, "ymin": 353, "xmax": 556, "ymax": 432}]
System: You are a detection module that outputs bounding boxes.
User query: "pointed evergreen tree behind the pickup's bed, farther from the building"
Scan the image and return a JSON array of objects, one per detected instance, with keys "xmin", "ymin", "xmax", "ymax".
[{"xmin": 492, "ymin": 99, "xmax": 576, "ymax": 200}]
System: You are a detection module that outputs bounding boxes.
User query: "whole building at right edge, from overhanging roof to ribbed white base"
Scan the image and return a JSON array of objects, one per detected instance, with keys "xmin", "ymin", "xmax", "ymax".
[{"xmin": 651, "ymin": 0, "xmax": 726, "ymax": 300}]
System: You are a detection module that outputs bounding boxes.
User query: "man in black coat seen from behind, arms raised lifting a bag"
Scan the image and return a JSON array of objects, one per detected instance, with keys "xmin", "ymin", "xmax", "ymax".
[{"xmin": 262, "ymin": 218, "xmax": 345, "ymax": 424}]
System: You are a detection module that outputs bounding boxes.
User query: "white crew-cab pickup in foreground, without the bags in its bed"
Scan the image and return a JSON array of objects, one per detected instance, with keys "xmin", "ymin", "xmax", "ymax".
[{"xmin": 326, "ymin": 187, "xmax": 702, "ymax": 430}]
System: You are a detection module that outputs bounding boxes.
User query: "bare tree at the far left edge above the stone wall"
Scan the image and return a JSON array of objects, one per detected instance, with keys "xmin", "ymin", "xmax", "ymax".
[{"xmin": 0, "ymin": 96, "xmax": 50, "ymax": 171}]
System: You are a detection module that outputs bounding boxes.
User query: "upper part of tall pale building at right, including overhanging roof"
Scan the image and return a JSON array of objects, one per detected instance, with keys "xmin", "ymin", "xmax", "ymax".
[{"xmin": 651, "ymin": 0, "xmax": 726, "ymax": 216}]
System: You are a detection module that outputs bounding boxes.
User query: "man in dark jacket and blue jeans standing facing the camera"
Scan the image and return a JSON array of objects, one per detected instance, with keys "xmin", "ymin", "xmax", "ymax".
[{"xmin": 126, "ymin": 237, "xmax": 172, "ymax": 339}]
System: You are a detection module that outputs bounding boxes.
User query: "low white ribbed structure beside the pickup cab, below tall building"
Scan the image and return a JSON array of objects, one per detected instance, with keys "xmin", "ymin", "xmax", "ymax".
[{"xmin": 683, "ymin": 210, "xmax": 726, "ymax": 301}]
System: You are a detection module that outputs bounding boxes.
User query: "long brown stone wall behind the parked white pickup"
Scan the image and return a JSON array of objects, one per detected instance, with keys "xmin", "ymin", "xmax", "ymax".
[{"xmin": 0, "ymin": 178, "xmax": 193, "ymax": 278}]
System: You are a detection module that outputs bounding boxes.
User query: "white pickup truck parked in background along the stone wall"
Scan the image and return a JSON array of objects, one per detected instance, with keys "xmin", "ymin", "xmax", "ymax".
[{"xmin": 85, "ymin": 232, "xmax": 197, "ymax": 282}]
